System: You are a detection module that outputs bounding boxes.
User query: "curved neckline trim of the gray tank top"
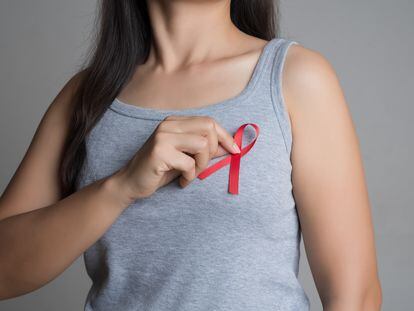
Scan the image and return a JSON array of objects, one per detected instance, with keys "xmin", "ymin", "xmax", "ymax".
[{"xmin": 109, "ymin": 37, "xmax": 282, "ymax": 120}]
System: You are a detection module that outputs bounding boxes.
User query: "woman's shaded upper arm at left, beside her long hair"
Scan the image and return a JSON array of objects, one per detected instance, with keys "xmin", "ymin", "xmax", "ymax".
[{"xmin": 0, "ymin": 71, "xmax": 82, "ymax": 220}]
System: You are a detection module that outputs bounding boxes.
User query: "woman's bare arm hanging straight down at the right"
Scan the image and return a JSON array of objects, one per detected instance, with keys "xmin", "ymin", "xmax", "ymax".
[{"xmin": 283, "ymin": 45, "xmax": 379, "ymax": 308}]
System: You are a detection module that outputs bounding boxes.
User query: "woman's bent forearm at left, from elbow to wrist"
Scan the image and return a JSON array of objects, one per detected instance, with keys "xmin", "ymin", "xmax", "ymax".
[{"xmin": 0, "ymin": 172, "xmax": 129, "ymax": 299}]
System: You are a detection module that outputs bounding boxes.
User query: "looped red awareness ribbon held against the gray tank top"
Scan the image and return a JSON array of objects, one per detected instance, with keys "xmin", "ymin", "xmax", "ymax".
[{"xmin": 197, "ymin": 123, "xmax": 259, "ymax": 194}]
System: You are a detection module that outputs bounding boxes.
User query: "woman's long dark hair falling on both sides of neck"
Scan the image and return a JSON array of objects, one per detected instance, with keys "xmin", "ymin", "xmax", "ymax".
[{"xmin": 59, "ymin": 0, "xmax": 279, "ymax": 196}]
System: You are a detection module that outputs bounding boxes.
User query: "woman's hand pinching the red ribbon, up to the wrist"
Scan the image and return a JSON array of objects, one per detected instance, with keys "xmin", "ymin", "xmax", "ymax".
[{"xmin": 114, "ymin": 116, "xmax": 240, "ymax": 202}]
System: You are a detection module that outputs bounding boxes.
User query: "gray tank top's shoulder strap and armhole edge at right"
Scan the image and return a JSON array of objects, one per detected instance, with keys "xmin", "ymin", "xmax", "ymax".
[{"xmin": 260, "ymin": 37, "xmax": 299, "ymax": 155}]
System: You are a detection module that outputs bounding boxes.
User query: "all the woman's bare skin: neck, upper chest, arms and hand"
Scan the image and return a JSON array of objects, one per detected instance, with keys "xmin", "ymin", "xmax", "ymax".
[{"xmin": 0, "ymin": 0, "xmax": 381, "ymax": 311}]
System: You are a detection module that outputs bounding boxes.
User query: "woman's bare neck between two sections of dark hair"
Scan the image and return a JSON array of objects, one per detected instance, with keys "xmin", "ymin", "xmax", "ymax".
[{"xmin": 147, "ymin": 0, "xmax": 246, "ymax": 71}]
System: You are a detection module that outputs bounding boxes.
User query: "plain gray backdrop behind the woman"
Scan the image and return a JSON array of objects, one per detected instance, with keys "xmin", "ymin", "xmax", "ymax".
[{"xmin": 0, "ymin": 0, "xmax": 414, "ymax": 311}]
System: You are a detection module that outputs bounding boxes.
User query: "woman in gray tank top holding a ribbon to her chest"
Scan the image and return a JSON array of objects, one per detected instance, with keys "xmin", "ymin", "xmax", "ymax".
[{"xmin": 0, "ymin": 0, "xmax": 381, "ymax": 310}]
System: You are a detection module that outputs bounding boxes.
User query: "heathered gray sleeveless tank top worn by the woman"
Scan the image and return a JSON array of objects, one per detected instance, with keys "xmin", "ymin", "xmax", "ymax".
[{"xmin": 78, "ymin": 37, "xmax": 310, "ymax": 311}]
